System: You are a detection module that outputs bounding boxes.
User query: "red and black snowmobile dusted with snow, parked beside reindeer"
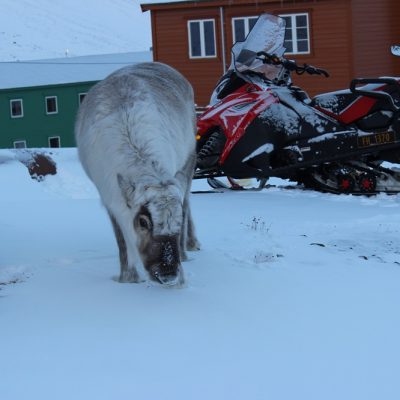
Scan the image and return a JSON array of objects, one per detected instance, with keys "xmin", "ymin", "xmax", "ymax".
[{"xmin": 194, "ymin": 14, "xmax": 400, "ymax": 194}]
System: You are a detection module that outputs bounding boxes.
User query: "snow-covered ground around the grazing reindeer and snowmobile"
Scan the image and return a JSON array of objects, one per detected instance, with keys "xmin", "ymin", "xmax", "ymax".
[{"xmin": 0, "ymin": 149, "xmax": 400, "ymax": 400}]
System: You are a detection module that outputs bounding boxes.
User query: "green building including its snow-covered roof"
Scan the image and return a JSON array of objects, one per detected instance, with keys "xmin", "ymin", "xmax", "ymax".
[{"xmin": 0, "ymin": 52, "xmax": 152, "ymax": 148}]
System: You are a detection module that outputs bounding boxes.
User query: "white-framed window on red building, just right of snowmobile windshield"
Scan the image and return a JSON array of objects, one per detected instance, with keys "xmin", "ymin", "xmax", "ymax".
[{"xmin": 280, "ymin": 14, "xmax": 310, "ymax": 54}]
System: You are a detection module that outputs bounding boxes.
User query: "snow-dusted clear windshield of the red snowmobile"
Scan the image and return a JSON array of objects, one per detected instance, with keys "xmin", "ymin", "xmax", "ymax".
[{"xmin": 230, "ymin": 14, "xmax": 286, "ymax": 80}]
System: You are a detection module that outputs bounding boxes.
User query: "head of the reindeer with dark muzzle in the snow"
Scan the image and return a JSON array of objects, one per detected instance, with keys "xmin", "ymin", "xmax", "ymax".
[{"xmin": 118, "ymin": 175, "xmax": 184, "ymax": 285}]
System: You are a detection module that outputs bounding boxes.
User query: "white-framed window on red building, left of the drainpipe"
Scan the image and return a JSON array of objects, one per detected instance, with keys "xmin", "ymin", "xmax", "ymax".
[{"xmin": 188, "ymin": 19, "xmax": 217, "ymax": 58}]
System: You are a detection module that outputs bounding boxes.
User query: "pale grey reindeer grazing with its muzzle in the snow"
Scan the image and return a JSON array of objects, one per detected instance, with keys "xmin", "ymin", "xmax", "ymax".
[{"xmin": 75, "ymin": 62, "xmax": 199, "ymax": 285}]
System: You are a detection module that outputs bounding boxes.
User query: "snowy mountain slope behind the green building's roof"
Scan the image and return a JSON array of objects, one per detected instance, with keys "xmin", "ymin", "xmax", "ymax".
[{"xmin": 0, "ymin": 0, "xmax": 151, "ymax": 61}]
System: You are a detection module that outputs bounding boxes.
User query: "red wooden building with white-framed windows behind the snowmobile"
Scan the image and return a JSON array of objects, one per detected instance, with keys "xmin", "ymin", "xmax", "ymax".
[{"xmin": 141, "ymin": 0, "xmax": 400, "ymax": 106}]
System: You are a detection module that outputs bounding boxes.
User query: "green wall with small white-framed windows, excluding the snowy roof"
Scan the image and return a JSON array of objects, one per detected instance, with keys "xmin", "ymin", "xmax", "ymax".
[{"xmin": 0, "ymin": 81, "xmax": 96, "ymax": 148}]
